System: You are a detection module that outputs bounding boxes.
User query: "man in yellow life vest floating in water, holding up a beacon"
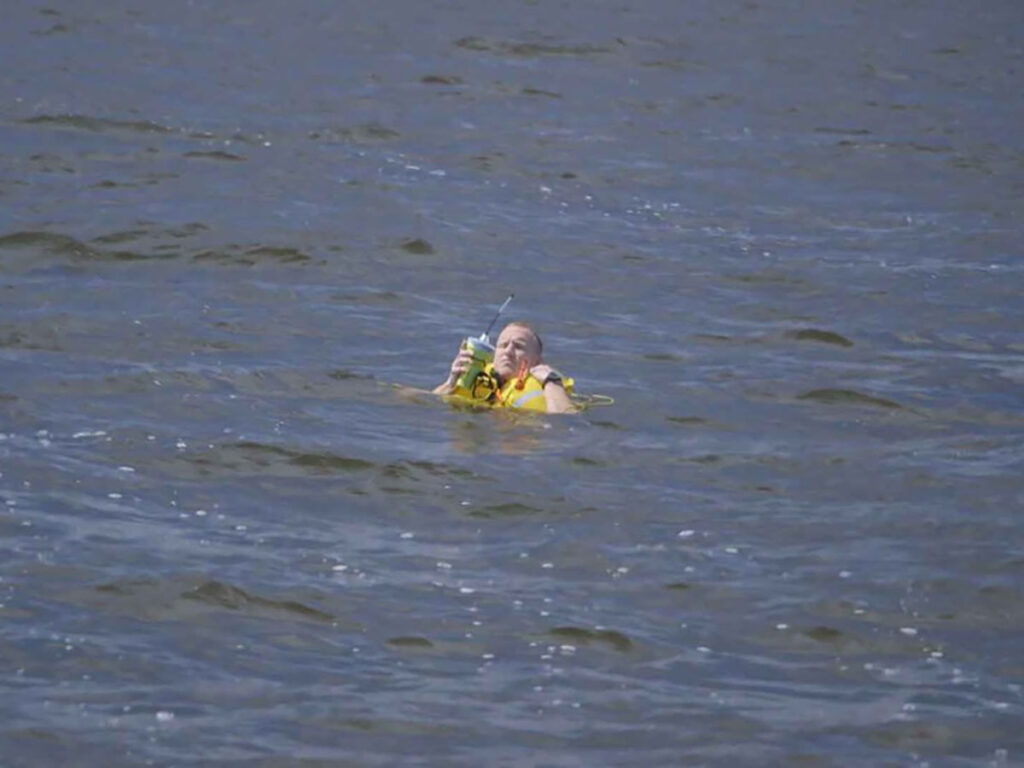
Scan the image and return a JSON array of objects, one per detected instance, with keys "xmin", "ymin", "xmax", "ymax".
[{"xmin": 433, "ymin": 322, "xmax": 577, "ymax": 414}]
